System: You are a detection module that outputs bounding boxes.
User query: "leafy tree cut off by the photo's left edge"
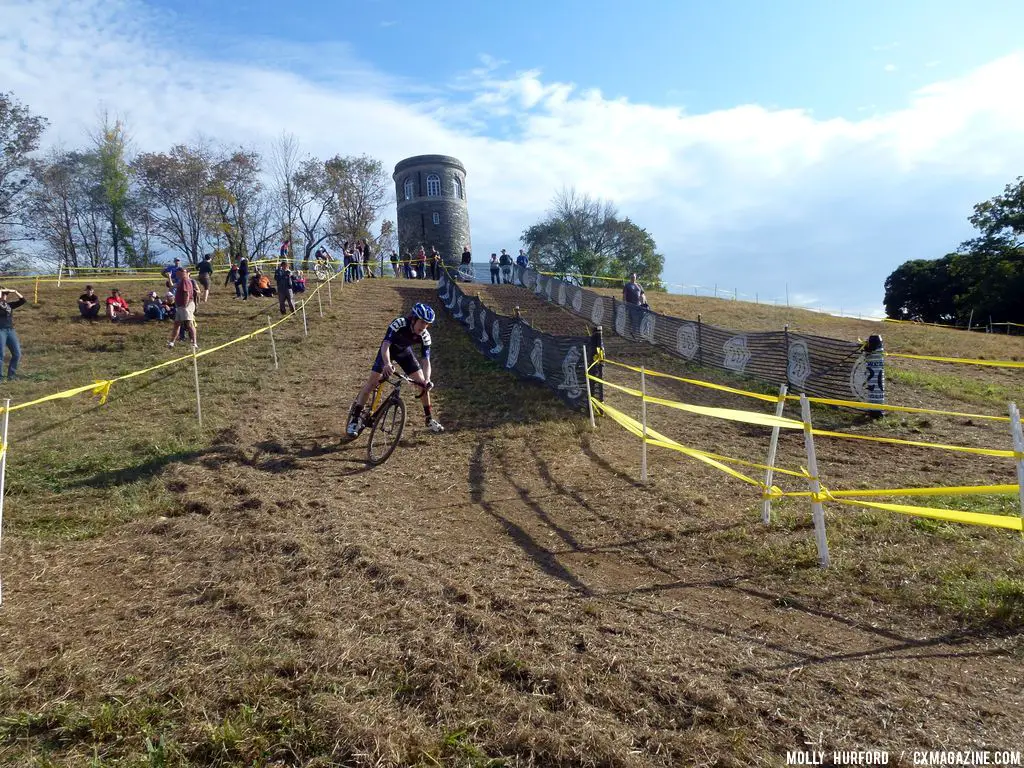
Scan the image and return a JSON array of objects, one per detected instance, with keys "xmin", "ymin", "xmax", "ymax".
[{"xmin": 0, "ymin": 93, "xmax": 48, "ymax": 256}]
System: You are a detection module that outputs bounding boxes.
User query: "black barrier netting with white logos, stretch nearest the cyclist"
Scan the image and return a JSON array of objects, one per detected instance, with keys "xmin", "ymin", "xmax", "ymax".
[{"xmin": 437, "ymin": 272, "xmax": 595, "ymax": 411}]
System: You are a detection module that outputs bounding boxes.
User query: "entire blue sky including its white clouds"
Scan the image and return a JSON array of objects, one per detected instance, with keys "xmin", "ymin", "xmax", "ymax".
[{"xmin": 0, "ymin": 0, "xmax": 1024, "ymax": 313}]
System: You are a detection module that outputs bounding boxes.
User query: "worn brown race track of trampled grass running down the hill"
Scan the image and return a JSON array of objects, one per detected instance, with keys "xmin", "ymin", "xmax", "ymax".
[{"xmin": 0, "ymin": 282, "xmax": 1024, "ymax": 766}]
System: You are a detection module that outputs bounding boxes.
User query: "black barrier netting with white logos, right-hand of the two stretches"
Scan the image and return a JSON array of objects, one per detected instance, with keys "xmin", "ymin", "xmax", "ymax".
[{"xmin": 515, "ymin": 267, "xmax": 869, "ymax": 402}]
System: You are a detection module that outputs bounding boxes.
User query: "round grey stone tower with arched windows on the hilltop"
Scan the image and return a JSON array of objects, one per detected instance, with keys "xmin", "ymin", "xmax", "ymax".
[{"xmin": 391, "ymin": 155, "xmax": 472, "ymax": 264}]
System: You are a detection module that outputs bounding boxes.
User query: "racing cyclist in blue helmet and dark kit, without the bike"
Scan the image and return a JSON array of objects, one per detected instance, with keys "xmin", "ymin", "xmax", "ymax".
[{"xmin": 345, "ymin": 303, "xmax": 444, "ymax": 437}]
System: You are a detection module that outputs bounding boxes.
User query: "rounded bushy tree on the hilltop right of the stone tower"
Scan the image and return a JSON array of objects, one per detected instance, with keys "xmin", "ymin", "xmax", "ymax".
[{"xmin": 520, "ymin": 188, "xmax": 665, "ymax": 291}]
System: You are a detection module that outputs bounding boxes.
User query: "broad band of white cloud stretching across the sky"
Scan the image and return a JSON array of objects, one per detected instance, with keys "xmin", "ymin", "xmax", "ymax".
[{"xmin": 0, "ymin": 0, "xmax": 1024, "ymax": 315}]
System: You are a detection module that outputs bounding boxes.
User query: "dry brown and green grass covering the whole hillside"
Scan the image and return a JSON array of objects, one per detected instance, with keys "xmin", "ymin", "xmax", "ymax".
[{"xmin": 0, "ymin": 281, "xmax": 1024, "ymax": 766}]
